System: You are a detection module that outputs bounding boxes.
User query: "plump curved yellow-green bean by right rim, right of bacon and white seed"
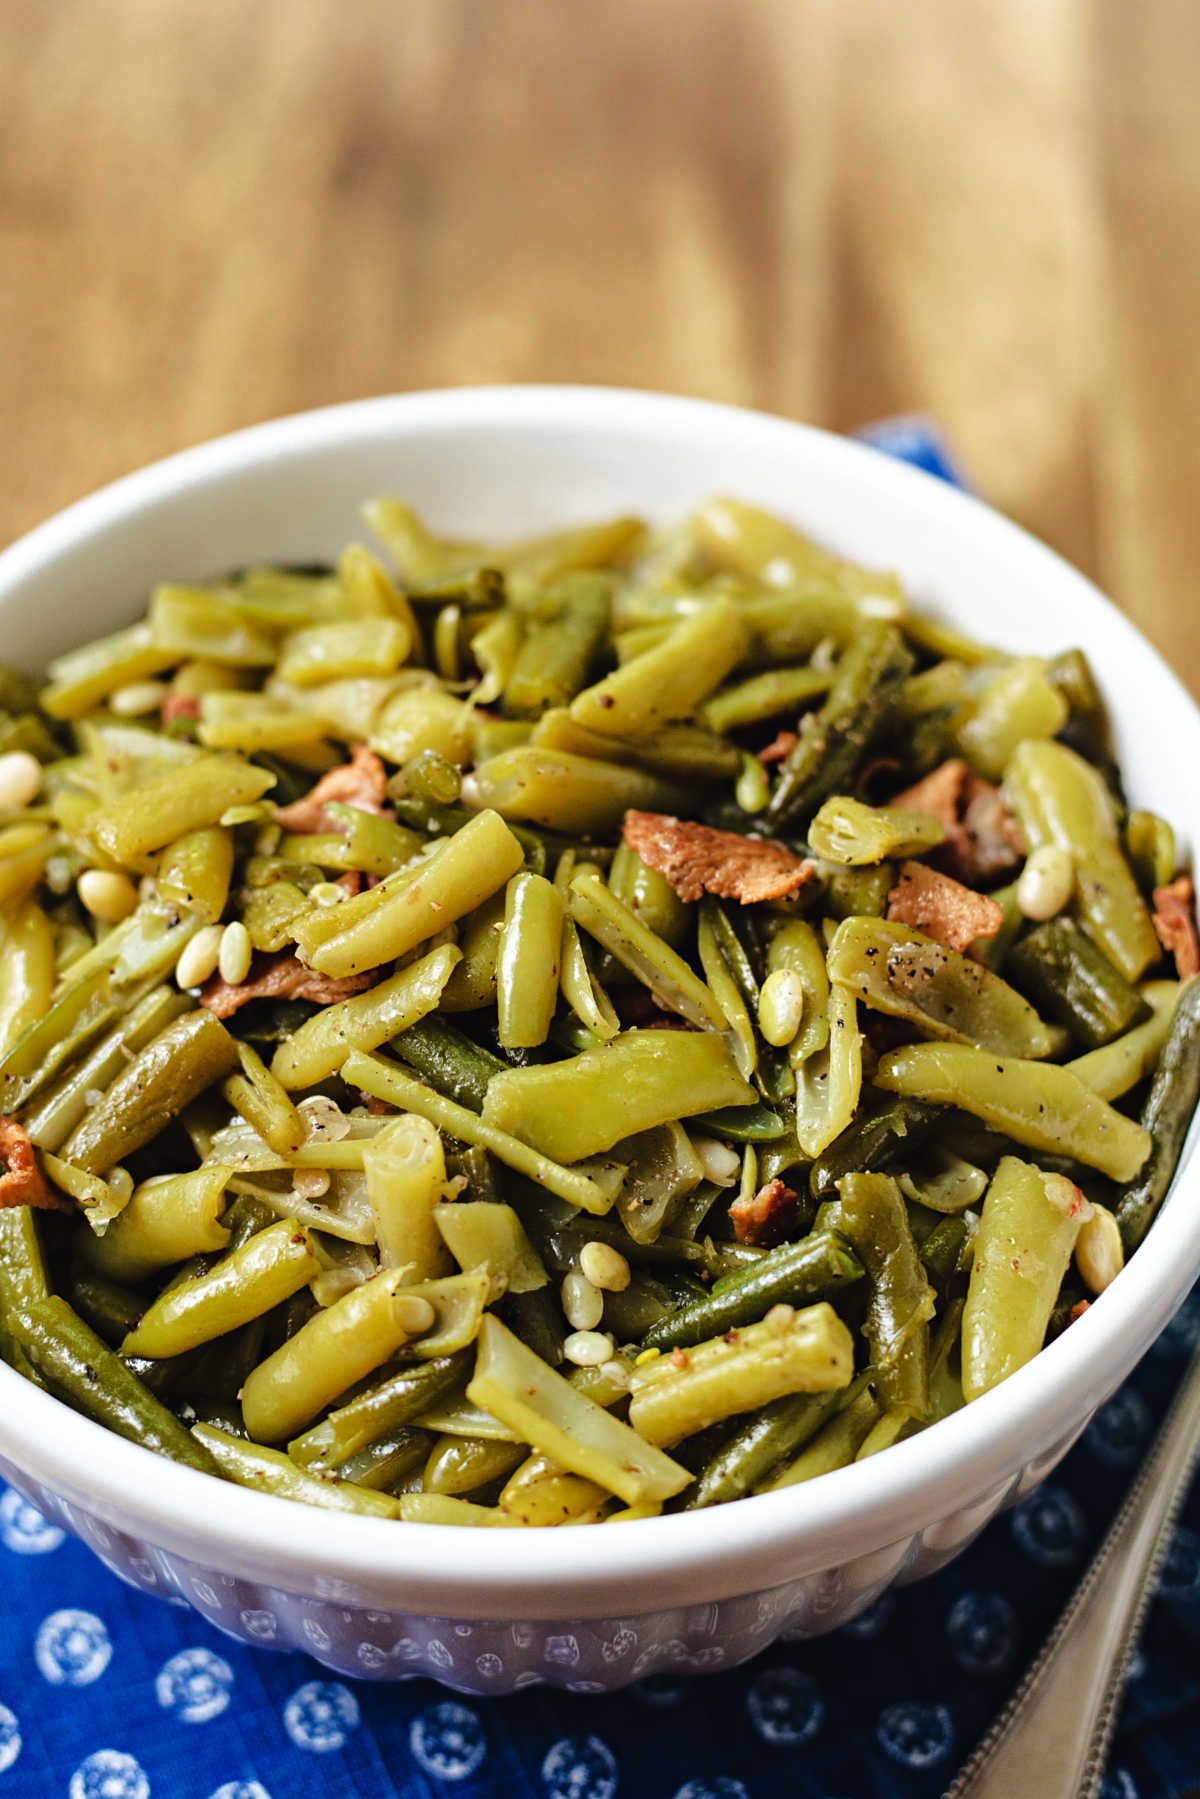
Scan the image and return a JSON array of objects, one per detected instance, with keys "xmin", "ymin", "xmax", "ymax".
[{"xmin": 1007, "ymin": 743, "xmax": 1160, "ymax": 980}]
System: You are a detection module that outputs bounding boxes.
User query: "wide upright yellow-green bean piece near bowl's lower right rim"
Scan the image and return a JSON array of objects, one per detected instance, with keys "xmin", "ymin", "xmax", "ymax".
[{"xmin": 963, "ymin": 1155, "xmax": 1087, "ymax": 1400}]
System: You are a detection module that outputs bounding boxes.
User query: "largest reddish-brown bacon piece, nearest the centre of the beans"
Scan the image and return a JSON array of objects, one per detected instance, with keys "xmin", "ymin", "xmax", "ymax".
[{"xmin": 624, "ymin": 811, "xmax": 813, "ymax": 905}]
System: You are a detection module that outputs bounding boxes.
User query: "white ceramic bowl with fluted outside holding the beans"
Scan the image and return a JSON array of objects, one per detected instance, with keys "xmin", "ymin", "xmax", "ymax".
[{"xmin": 0, "ymin": 387, "xmax": 1200, "ymax": 1693}]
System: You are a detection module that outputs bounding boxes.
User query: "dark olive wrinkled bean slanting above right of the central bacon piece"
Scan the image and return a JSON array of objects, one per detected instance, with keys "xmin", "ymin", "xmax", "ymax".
[{"xmin": 766, "ymin": 621, "xmax": 912, "ymax": 829}]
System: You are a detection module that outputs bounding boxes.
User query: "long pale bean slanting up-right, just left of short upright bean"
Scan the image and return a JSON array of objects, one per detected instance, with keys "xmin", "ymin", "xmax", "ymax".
[{"xmin": 295, "ymin": 811, "xmax": 524, "ymax": 979}]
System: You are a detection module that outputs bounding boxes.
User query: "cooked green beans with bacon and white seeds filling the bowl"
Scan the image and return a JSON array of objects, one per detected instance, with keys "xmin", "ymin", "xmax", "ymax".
[{"xmin": 0, "ymin": 390, "xmax": 1200, "ymax": 1677}]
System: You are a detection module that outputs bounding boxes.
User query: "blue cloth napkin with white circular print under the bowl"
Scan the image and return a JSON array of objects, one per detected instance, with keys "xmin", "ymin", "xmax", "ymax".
[{"xmin": 0, "ymin": 419, "xmax": 1200, "ymax": 1799}]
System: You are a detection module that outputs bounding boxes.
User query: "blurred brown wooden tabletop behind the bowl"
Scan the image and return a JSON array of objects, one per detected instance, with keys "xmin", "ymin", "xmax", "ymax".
[{"xmin": 0, "ymin": 0, "xmax": 1200, "ymax": 691}]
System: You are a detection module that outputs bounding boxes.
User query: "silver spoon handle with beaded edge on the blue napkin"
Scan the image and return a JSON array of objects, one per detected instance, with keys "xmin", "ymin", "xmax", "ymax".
[{"xmin": 943, "ymin": 1349, "xmax": 1200, "ymax": 1799}]
